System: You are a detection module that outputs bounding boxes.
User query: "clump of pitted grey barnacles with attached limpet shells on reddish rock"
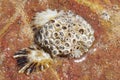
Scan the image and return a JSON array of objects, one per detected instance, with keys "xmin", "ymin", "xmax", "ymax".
[{"xmin": 14, "ymin": 9, "xmax": 95, "ymax": 74}]
